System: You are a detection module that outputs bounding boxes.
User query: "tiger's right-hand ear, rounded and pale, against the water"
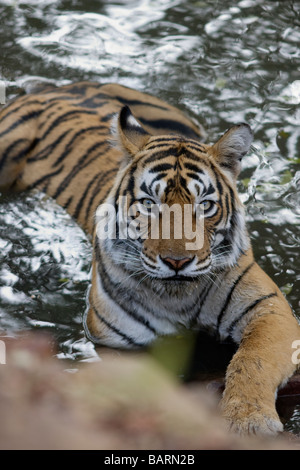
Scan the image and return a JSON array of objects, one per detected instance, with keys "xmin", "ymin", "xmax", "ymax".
[{"xmin": 212, "ymin": 123, "xmax": 253, "ymax": 179}]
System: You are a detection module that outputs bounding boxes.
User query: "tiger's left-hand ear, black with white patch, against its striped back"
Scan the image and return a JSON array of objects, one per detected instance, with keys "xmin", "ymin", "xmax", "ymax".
[{"xmin": 118, "ymin": 106, "xmax": 151, "ymax": 156}]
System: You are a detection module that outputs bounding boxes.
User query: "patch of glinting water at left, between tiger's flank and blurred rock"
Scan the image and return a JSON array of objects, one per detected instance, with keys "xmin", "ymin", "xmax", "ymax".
[{"xmin": 0, "ymin": 193, "xmax": 95, "ymax": 359}]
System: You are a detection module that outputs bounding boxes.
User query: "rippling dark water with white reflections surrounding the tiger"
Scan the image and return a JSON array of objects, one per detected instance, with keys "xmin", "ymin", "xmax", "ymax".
[{"xmin": 0, "ymin": 0, "xmax": 300, "ymax": 432}]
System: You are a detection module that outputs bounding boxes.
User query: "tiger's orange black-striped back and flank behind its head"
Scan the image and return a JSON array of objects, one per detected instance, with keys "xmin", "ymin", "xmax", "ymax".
[{"xmin": 0, "ymin": 82, "xmax": 204, "ymax": 233}]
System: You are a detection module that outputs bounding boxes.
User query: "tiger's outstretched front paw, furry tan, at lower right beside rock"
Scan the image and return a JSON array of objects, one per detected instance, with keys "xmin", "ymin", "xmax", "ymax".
[{"xmin": 222, "ymin": 403, "xmax": 283, "ymax": 437}]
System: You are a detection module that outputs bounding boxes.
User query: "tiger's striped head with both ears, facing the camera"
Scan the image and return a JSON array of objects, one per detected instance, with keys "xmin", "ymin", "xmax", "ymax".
[{"xmin": 97, "ymin": 107, "xmax": 253, "ymax": 282}]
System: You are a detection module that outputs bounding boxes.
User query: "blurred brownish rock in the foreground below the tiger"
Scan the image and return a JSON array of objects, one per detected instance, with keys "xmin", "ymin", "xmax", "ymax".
[{"xmin": 0, "ymin": 334, "xmax": 299, "ymax": 450}]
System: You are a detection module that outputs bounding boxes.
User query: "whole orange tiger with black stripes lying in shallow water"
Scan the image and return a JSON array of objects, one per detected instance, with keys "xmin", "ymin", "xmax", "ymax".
[{"xmin": 0, "ymin": 81, "xmax": 300, "ymax": 435}]
